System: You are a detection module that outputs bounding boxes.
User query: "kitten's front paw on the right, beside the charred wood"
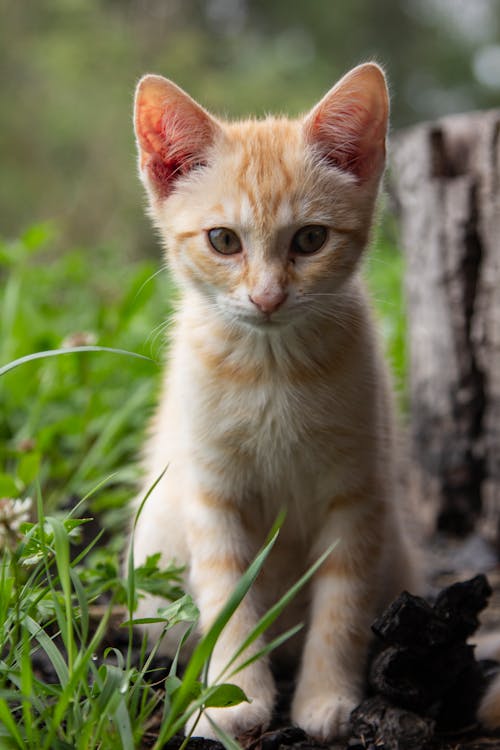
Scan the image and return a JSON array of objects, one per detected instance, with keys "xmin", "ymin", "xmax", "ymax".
[{"xmin": 292, "ymin": 693, "xmax": 359, "ymax": 742}]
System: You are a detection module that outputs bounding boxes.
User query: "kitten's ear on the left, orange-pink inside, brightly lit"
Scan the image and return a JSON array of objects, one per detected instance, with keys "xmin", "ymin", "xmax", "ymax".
[{"xmin": 134, "ymin": 75, "xmax": 219, "ymax": 198}]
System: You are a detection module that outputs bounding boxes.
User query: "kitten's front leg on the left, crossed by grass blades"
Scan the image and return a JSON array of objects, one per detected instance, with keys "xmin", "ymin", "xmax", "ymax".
[{"xmin": 187, "ymin": 490, "xmax": 275, "ymax": 738}]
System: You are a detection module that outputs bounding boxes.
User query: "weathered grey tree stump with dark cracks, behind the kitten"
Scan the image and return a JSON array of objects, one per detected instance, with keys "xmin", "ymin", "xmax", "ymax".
[{"xmin": 391, "ymin": 110, "xmax": 500, "ymax": 544}]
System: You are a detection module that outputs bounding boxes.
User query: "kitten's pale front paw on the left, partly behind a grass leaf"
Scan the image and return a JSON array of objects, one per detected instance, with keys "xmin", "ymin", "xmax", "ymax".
[{"xmin": 186, "ymin": 698, "xmax": 272, "ymax": 740}]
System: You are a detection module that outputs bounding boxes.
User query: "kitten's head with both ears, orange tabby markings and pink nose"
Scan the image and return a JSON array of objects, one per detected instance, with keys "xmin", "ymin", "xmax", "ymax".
[{"xmin": 136, "ymin": 64, "xmax": 388, "ymax": 331}]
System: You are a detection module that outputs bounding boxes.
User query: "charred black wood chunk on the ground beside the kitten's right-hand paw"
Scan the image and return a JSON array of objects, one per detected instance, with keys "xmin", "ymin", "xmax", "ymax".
[{"xmin": 360, "ymin": 575, "xmax": 491, "ymax": 746}]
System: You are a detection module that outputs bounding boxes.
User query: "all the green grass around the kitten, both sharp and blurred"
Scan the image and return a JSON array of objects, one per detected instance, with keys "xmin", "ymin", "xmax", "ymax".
[{"xmin": 0, "ymin": 223, "xmax": 405, "ymax": 750}]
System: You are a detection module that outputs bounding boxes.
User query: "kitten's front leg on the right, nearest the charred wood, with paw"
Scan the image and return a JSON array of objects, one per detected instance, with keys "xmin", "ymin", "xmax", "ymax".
[{"xmin": 292, "ymin": 493, "xmax": 385, "ymax": 741}]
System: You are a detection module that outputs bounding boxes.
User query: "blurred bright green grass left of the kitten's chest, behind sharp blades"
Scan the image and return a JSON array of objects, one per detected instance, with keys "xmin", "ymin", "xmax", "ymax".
[{"xmin": 0, "ymin": 227, "xmax": 178, "ymax": 548}]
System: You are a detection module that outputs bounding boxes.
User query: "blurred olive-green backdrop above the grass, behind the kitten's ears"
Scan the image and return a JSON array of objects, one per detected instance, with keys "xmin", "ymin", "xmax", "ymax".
[{"xmin": 0, "ymin": 0, "xmax": 500, "ymax": 257}]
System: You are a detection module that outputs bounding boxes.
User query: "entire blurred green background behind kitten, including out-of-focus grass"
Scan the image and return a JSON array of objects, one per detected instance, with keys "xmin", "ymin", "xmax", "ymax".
[{"xmin": 0, "ymin": 0, "xmax": 500, "ymax": 528}]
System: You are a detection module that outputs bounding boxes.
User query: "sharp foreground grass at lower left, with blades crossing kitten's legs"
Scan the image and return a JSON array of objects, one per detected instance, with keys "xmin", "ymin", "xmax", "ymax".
[{"xmin": 0, "ymin": 488, "xmax": 335, "ymax": 750}]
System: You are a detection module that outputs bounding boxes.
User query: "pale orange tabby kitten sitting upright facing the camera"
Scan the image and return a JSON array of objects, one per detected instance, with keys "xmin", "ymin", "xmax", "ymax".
[{"xmin": 134, "ymin": 63, "xmax": 415, "ymax": 740}]
